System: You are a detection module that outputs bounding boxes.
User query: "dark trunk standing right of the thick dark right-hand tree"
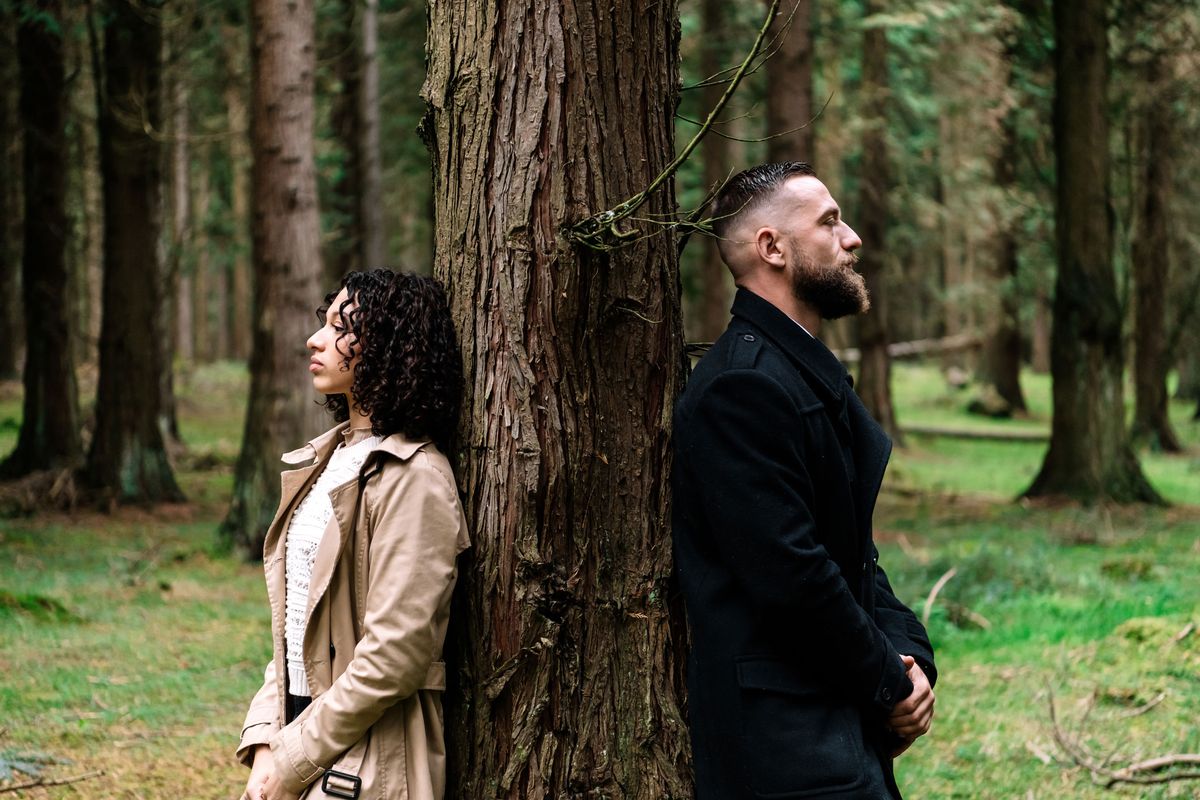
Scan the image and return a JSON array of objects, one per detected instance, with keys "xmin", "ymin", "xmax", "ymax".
[{"xmin": 1132, "ymin": 54, "xmax": 1182, "ymax": 452}]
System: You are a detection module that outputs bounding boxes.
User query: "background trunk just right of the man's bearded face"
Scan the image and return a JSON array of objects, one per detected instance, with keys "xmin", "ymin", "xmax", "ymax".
[{"xmin": 856, "ymin": 0, "xmax": 902, "ymax": 444}]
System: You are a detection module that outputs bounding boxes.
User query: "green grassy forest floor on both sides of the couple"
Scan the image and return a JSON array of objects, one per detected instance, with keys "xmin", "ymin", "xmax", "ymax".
[{"xmin": 0, "ymin": 365, "xmax": 1200, "ymax": 800}]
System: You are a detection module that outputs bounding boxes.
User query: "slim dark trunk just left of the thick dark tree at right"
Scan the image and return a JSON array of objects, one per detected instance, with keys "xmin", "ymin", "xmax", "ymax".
[{"xmin": 983, "ymin": 104, "xmax": 1027, "ymax": 411}]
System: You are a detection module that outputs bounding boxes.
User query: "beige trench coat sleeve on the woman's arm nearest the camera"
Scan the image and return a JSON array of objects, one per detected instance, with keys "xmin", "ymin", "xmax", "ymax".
[{"xmin": 270, "ymin": 452, "xmax": 463, "ymax": 793}]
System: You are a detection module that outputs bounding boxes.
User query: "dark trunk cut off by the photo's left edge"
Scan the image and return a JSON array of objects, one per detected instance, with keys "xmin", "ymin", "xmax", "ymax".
[{"xmin": 0, "ymin": 7, "xmax": 24, "ymax": 380}]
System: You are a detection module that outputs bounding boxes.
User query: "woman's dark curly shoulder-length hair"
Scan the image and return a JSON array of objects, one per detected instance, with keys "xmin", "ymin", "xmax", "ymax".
[{"xmin": 317, "ymin": 270, "xmax": 462, "ymax": 450}]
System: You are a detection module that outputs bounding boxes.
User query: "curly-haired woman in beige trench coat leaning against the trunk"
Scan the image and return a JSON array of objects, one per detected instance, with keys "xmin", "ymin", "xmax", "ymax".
[{"xmin": 238, "ymin": 270, "xmax": 469, "ymax": 800}]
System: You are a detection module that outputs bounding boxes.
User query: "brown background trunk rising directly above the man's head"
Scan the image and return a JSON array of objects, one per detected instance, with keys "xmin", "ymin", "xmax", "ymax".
[{"xmin": 768, "ymin": 0, "xmax": 821, "ymax": 160}]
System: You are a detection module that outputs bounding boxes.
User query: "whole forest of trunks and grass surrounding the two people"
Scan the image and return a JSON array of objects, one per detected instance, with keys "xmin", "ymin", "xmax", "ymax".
[{"xmin": 0, "ymin": 0, "xmax": 1200, "ymax": 798}]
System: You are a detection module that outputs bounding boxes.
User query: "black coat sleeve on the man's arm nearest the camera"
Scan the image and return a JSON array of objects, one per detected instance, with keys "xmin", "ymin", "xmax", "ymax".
[{"xmin": 676, "ymin": 369, "xmax": 912, "ymax": 712}]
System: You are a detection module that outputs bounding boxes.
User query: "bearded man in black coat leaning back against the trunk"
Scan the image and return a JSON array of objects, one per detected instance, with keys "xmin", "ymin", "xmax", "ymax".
[{"xmin": 673, "ymin": 162, "xmax": 936, "ymax": 800}]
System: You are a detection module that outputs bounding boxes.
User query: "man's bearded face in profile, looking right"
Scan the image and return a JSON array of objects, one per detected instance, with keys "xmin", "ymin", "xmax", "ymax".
[{"xmin": 775, "ymin": 175, "xmax": 871, "ymax": 319}]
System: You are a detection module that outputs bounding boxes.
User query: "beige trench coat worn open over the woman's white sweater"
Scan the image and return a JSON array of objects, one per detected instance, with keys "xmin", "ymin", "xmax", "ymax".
[{"xmin": 238, "ymin": 423, "xmax": 469, "ymax": 800}]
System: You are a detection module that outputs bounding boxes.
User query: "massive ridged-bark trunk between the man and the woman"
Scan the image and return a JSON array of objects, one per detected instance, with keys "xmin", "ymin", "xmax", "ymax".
[{"xmin": 425, "ymin": 0, "xmax": 692, "ymax": 800}]
